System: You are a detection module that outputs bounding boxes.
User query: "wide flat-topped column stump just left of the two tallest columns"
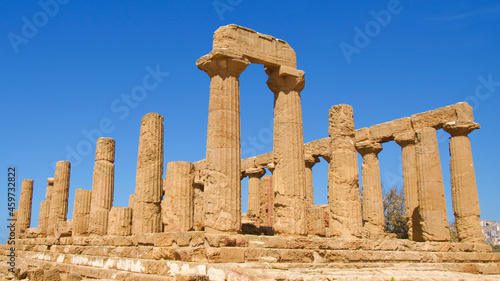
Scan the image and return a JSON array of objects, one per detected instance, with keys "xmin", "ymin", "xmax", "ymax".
[{"xmin": 161, "ymin": 161, "xmax": 194, "ymax": 232}]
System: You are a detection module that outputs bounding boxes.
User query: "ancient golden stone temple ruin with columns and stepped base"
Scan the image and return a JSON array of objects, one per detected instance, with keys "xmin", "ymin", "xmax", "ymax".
[{"xmin": 2, "ymin": 25, "xmax": 500, "ymax": 280}]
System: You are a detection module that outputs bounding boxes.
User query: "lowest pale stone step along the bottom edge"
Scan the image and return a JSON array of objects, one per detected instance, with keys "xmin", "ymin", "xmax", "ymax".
[{"xmin": 0, "ymin": 254, "xmax": 500, "ymax": 281}]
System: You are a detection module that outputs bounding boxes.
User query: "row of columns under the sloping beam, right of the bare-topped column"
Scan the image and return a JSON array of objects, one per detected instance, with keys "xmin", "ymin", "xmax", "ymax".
[{"xmin": 356, "ymin": 120, "xmax": 484, "ymax": 243}]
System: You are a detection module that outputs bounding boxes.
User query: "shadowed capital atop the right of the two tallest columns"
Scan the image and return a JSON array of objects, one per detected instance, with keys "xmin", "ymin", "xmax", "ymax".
[{"xmin": 264, "ymin": 65, "xmax": 306, "ymax": 94}]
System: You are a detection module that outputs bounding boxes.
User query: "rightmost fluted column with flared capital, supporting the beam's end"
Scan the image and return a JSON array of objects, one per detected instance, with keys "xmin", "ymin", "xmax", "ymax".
[{"xmin": 443, "ymin": 120, "xmax": 484, "ymax": 243}]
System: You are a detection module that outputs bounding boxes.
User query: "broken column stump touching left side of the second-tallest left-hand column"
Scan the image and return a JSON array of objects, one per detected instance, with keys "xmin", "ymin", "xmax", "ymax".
[{"xmin": 73, "ymin": 189, "xmax": 92, "ymax": 236}]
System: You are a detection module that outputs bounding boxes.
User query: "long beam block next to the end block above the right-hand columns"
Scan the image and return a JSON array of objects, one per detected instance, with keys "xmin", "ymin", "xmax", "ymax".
[{"xmin": 411, "ymin": 105, "xmax": 457, "ymax": 131}]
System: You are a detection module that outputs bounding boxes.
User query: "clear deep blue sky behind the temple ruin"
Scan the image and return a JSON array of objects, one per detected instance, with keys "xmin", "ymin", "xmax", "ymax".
[{"xmin": 0, "ymin": 0, "xmax": 500, "ymax": 240}]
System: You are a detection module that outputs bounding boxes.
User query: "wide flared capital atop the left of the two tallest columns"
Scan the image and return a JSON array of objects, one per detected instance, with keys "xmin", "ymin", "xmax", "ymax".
[{"xmin": 196, "ymin": 49, "xmax": 250, "ymax": 78}]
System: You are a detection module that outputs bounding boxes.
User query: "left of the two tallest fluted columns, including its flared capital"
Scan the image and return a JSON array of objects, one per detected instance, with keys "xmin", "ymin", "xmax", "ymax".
[{"xmin": 196, "ymin": 49, "xmax": 250, "ymax": 232}]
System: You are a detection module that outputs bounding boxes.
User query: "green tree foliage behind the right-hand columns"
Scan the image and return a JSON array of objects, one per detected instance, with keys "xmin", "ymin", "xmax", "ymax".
[{"xmin": 383, "ymin": 187, "xmax": 408, "ymax": 239}]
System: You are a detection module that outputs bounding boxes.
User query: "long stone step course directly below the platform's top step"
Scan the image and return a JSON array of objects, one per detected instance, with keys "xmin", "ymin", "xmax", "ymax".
[{"xmin": 10, "ymin": 246, "xmax": 500, "ymax": 264}]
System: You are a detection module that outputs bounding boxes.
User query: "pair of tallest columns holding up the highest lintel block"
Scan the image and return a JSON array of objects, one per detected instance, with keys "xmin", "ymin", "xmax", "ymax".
[{"xmin": 196, "ymin": 49, "xmax": 307, "ymax": 235}]
